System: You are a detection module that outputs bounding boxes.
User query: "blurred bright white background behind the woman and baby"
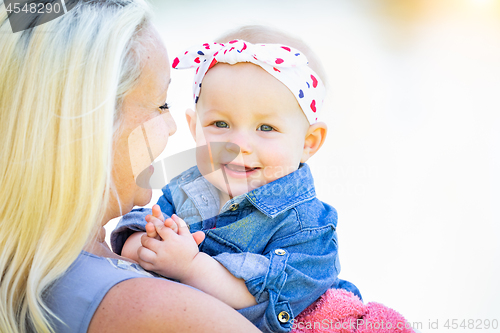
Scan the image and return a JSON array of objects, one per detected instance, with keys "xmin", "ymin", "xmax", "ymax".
[{"xmin": 104, "ymin": 0, "xmax": 500, "ymax": 326}]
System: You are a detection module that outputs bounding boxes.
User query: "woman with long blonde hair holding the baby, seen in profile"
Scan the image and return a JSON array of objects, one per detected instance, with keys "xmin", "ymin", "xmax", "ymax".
[{"xmin": 0, "ymin": 0, "xmax": 257, "ymax": 332}]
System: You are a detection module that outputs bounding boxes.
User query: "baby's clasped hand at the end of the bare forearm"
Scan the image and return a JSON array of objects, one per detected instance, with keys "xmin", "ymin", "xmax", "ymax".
[{"xmin": 138, "ymin": 215, "xmax": 199, "ymax": 281}]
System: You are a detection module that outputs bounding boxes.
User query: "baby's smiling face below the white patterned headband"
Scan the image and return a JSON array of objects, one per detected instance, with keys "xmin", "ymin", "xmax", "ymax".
[{"xmin": 191, "ymin": 63, "xmax": 309, "ymax": 196}]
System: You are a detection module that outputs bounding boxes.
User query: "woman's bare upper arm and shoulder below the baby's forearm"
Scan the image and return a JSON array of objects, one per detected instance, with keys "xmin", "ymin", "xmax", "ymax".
[{"xmin": 88, "ymin": 278, "xmax": 260, "ymax": 333}]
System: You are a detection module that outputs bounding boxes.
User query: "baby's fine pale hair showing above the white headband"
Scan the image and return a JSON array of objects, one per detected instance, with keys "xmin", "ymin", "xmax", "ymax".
[{"xmin": 215, "ymin": 25, "xmax": 327, "ymax": 85}]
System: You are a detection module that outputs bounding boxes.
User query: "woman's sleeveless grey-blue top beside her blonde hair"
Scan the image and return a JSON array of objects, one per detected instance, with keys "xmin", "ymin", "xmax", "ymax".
[{"xmin": 44, "ymin": 251, "xmax": 153, "ymax": 333}]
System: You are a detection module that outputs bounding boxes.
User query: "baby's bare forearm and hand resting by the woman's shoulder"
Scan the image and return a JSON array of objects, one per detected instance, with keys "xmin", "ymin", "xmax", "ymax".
[{"xmin": 138, "ymin": 215, "xmax": 257, "ymax": 309}]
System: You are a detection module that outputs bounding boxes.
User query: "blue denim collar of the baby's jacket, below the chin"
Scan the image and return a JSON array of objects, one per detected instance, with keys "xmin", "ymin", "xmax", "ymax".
[{"xmin": 179, "ymin": 163, "xmax": 316, "ymax": 220}]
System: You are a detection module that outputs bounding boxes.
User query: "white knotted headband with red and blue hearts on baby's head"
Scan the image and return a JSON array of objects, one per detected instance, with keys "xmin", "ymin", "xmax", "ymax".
[{"xmin": 172, "ymin": 40, "xmax": 326, "ymax": 124}]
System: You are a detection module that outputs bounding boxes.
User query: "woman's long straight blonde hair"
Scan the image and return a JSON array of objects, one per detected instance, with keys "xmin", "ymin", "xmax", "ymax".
[{"xmin": 0, "ymin": 0, "xmax": 150, "ymax": 332}]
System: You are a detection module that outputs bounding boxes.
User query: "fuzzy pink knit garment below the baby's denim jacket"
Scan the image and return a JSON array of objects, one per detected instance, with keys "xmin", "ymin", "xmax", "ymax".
[{"xmin": 292, "ymin": 289, "xmax": 414, "ymax": 333}]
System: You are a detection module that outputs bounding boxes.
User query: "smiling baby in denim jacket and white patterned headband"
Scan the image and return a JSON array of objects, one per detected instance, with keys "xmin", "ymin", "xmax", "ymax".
[{"xmin": 111, "ymin": 26, "xmax": 360, "ymax": 332}]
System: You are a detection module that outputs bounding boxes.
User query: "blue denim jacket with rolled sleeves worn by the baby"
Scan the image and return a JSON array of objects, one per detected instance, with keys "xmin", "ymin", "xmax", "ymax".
[{"xmin": 111, "ymin": 164, "xmax": 361, "ymax": 332}]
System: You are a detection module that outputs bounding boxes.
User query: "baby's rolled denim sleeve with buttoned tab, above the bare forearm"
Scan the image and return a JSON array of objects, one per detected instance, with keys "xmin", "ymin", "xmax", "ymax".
[{"xmin": 209, "ymin": 226, "xmax": 339, "ymax": 332}]
